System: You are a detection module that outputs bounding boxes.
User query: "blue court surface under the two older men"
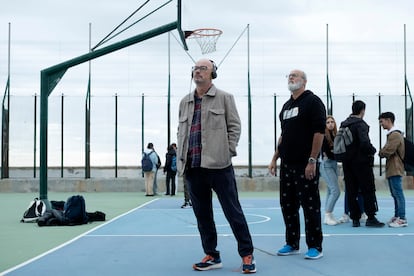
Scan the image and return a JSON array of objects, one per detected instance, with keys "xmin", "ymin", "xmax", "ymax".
[{"xmin": 5, "ymin": 196, "xmax": 414, "ymax": 276}]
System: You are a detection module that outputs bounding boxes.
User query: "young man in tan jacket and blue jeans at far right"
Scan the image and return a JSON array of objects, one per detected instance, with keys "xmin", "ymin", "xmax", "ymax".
[{"xmin": 378, "ymin": 112, "xmax": 408, "ymax": 227}]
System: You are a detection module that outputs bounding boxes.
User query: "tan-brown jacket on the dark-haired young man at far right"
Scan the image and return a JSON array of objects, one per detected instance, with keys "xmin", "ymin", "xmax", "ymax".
[{"xmin": 379, "ymin": 131, "xmax": 405, "ymax": 178}]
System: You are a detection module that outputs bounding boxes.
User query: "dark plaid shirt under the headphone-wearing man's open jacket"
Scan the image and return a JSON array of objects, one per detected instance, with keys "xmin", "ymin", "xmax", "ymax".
[{"xmin": 188, "ymin": 95, "xmax": 202, "ymax": 168}]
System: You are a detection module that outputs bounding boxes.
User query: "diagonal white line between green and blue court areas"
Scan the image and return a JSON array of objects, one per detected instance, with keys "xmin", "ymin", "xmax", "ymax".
[{"xmin": 0, "ymin": 198, "xmax": 159, "ymax": 275}]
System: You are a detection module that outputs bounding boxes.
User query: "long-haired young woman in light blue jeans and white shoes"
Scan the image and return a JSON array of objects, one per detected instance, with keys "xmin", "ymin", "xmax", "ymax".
[{"xmin": 320, "ymin": 115, "xmax": 341, "ymax": 225}]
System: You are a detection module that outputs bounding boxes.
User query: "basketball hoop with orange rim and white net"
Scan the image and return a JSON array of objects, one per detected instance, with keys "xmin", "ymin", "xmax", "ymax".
[{"xmin": 185, "ymin": 28, "xmax": 223, "ymax": 55}]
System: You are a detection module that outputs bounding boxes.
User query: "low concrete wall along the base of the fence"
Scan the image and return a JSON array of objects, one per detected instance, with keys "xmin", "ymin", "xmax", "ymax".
[{"xmin": 0, "ymin": 167, "xmax": 414, "ymax": 194}]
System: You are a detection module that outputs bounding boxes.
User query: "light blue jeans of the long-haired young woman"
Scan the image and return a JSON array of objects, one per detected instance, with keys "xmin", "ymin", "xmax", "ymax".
[{"xmin": 320, "ymin": 159, "xmax": 341, "ymax": 213}]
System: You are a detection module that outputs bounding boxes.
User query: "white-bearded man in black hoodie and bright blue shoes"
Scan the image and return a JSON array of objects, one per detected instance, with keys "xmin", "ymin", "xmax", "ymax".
[{"xmin": 269, "ymin": 70, "xmax": 326, "ymax": 259}]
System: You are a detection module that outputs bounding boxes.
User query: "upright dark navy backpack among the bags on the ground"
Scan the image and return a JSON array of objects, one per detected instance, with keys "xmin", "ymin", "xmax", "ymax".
[{"xmin": 52, "ymin": 195, "xmax": 88, "ymax": 225}]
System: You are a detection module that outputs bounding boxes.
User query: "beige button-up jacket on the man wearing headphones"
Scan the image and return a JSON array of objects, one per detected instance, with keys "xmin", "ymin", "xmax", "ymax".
[{"xmin": 177, "ymin": 85, "xmax": 241, "ymax": 175}]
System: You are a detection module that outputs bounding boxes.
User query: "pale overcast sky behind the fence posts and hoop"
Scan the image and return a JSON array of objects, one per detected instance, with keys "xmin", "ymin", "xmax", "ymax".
[{"xmin": 0, "ymin": 0, "xmax": 414, "ymax": 166}]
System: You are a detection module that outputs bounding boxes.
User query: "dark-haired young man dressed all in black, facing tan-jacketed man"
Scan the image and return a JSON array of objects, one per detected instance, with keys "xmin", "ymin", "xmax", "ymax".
[{"xmin": 340, "ymin": 100, "xmax": 385, "ymax": 227}]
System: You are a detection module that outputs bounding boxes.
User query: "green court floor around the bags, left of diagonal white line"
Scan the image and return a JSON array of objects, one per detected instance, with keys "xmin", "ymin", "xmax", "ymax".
[{"xmin": 0, "ymin": 192, "xmax": 151, "ymax": 272}]
